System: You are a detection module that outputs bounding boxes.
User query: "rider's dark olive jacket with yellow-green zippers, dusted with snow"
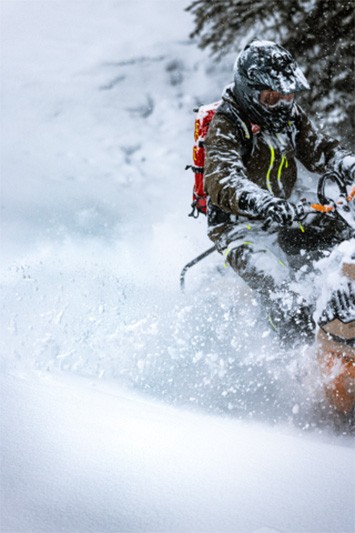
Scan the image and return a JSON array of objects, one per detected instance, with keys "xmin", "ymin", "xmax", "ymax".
[{"xmin": 204, "ymin": 87, "xmax": 349, "ymax": 246}]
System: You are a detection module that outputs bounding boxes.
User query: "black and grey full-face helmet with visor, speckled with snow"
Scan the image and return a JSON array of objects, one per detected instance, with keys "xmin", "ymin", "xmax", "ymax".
[{"xmin": 233, "ymin": 40, "xmax": 309, "ymax": 132}]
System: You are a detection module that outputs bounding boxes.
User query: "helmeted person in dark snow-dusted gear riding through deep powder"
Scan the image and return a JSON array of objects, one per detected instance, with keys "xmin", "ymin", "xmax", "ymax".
[{"xmin": 204, "ymin": 40, "xmax": 355, "ymax": 339}]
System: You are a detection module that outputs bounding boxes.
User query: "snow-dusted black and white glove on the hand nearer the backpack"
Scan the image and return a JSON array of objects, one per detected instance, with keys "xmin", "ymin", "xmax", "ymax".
[{"xmin": 238, "ymin": 191, "xmax": 297, "ymax": 226}]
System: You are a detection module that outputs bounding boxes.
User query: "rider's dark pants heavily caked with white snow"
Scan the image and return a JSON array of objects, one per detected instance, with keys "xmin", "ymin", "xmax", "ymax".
[{"xmin": 211, "ymin": 217, "xmax": 352, "ymax": 345}]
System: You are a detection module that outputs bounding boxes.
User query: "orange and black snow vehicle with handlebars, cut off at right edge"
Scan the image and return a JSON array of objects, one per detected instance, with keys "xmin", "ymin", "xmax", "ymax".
[{"xmin": 180, "ymin": 171, "xmax": 355, "ymax": 416}]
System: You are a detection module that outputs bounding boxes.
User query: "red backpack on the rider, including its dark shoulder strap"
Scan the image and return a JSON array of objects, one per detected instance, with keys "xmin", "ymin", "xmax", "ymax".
[{"xmin": 185, "ymin": 100, "xmax": 254, "ymax": 218}]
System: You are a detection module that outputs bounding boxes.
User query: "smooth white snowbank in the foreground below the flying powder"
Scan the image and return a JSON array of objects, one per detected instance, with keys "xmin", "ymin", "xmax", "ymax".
[{"xmin": 1, "ymin": 370, "xmax": 354, "ymax": 533}]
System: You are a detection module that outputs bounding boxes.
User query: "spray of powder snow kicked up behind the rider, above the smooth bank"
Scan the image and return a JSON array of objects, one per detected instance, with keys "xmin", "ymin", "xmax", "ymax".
[{"xmin": 1, "ymin": 246, "xmax": 320, "ymax": 426}]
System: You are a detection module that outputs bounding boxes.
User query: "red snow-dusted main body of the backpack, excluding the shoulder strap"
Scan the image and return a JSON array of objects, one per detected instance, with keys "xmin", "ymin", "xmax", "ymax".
[{"xmin": 186, "ymin": 100, "xmax": 221, "ymax": 218}]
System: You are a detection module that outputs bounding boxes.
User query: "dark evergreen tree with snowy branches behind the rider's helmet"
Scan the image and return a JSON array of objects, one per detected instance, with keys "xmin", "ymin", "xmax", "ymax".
[{"xmin": 187, "ymin": 0, "xmax": 355, "ymax": 141}]
